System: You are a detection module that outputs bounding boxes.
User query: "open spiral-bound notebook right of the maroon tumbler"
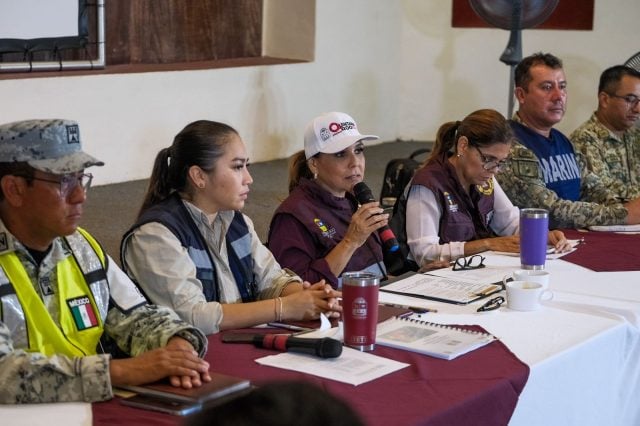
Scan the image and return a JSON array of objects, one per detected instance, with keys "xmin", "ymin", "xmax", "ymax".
[{"xmin": 376, "ymin": 317, "xmax": 495, "ymax": 360}]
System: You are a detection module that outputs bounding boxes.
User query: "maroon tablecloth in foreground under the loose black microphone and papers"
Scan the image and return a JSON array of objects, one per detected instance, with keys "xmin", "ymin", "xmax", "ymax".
[{"xmin": 93, "ymin": 327, "xmax": 529, "ymax": 426}]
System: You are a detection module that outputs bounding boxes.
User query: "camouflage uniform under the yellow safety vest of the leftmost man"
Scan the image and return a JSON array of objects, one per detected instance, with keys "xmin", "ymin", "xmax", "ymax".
[{"xmin": 0, "ymin": 221, "xmax": 207, "ymax": 403}]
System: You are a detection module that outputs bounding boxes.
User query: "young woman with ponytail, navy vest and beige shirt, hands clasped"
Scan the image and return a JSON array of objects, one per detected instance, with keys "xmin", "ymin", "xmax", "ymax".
[{"xmin": 121, "ymin": 120, "xmax": 340, "ymax": 334}]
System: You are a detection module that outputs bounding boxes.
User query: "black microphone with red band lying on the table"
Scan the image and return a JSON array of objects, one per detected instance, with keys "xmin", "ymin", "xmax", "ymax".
[{"xmin": 222, "ymin": 333, "xmax": 342, "ymax": 358}]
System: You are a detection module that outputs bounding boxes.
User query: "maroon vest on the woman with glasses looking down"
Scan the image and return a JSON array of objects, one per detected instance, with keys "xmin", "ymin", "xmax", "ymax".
[{"xmin": 411, "ymin": 154, "xmax": 495, "ymax": 244}]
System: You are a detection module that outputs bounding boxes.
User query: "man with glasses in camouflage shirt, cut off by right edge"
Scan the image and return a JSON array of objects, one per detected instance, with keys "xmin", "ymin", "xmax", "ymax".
[{"xmin": 570, "ymin": 65, "xmax": 640, "ymax": 200}]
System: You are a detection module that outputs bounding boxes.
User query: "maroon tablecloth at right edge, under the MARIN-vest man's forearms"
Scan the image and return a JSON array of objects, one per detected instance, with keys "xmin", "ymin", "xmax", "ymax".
[{"xmin": 562, "ymin": 229, "xmax": 640, "ymax": 272}]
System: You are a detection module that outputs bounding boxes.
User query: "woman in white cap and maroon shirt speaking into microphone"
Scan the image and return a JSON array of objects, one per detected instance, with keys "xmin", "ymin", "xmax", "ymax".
[{"xmin": 268, "ymin": 112, "xmax": 389, "ymax": 287}]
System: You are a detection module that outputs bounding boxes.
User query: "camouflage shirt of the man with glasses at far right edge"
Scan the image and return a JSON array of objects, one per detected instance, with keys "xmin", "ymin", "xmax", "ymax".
[{"xmin": 570, "ymin": 113, "xmax": 640, "ymax": 200}]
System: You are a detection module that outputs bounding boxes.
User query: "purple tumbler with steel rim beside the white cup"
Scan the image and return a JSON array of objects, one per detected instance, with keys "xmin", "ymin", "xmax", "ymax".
[{"xmin": 520, "ymin": 209, "xmax": 549, "ymax": 269}]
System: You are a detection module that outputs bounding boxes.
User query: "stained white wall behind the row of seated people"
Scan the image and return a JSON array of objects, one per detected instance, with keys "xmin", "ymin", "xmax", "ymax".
[{"xmin": 0, "ymin": 0, "xmax": 640, "ymax": 184}]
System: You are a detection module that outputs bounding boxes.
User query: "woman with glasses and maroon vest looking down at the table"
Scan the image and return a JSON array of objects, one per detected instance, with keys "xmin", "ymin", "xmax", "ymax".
[{"xmin": 406, "ymin": 109, "xmax": 569, "ymax": 266}]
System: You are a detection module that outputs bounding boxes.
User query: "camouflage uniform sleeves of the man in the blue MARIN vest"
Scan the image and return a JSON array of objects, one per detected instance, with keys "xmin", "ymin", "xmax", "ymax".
[{"xmin": 496, "ymin": 114, "xmax": 627, "ymax": 229}]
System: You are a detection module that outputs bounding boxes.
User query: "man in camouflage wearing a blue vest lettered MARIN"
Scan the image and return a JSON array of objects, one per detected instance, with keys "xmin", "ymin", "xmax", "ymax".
[{"xmin": 496, "ymin": 53, "xmax": 640, "ymax": 228}]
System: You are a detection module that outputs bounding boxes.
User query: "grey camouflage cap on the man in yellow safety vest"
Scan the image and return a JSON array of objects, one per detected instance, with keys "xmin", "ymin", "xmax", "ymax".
[{"xmin": 0, "ymin": 119, "xmax": 104, "ymax": 174}]
